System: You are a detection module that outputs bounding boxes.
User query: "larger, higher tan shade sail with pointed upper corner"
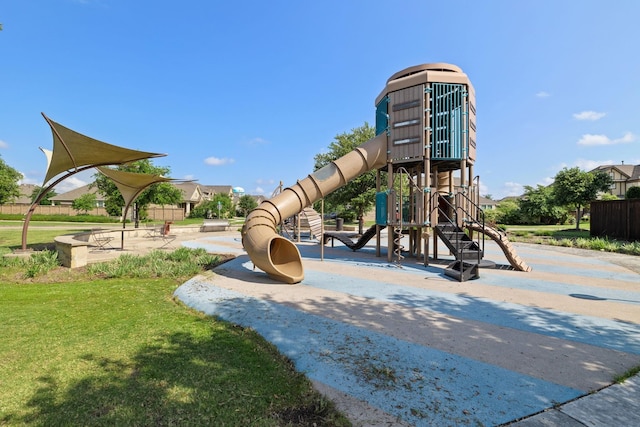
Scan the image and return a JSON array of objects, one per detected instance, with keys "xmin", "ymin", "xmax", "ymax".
[{"xmin": 42, "ymin": 113, "xmax": 166, "ymax": 186}]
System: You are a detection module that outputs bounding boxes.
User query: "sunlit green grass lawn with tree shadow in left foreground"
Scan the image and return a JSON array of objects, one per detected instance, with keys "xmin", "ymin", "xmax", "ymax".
[{"xmin": 0, "ymin": 226, "xmax": 349, "ymax": 426}]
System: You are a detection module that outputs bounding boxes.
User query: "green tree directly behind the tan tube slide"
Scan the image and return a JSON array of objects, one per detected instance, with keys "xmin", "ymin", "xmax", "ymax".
[{"xmin": 314, "ymin": 122, "xmax": 376, "ymax": 234}]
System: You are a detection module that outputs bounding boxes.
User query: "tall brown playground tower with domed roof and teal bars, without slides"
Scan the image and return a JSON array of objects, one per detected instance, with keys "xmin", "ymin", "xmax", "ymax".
[{"xmin": 375, "ymin": 63, "xmax": 478, "ymax": 262}]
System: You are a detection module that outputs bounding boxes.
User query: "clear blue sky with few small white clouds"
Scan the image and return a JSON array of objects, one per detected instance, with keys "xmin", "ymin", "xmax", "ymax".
[{"xmin": 0, "ymin": 0, "xmax": 640, "ymax": 199}]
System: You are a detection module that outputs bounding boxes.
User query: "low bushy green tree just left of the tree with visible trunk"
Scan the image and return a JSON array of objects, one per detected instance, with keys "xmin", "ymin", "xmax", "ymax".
[{"xmin": 518, "ymin": 184, "xmax": 568, "ymax": 225}]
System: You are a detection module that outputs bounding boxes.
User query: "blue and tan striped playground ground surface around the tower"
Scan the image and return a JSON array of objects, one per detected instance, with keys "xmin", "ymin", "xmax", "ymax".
[{"xmin": 176, "ymin": 233, "xmax": 640, "ymax": 426}]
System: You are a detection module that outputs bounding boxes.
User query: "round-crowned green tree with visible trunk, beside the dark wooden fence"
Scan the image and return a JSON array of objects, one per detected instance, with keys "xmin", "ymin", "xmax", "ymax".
[{"xmin": 553, "ymin": 167, "xmax": 613, "ymax": 230}]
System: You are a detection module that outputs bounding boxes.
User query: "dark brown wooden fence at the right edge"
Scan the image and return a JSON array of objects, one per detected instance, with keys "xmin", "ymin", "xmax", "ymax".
[{"xmin": 590, "ymin": 199, "xmax": 640, "ymax": 241}]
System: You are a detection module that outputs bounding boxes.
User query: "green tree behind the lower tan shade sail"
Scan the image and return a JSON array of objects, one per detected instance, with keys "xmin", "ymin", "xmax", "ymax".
[{"xmin": 92, "ymin": 159, "xmax": 182, "ymax": 220}]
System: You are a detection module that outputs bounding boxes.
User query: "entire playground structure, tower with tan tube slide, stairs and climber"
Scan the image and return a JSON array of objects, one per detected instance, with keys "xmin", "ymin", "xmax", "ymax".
[{"xmin": 242, "ymin": 63, "xmax": 530, "ymax": 283}]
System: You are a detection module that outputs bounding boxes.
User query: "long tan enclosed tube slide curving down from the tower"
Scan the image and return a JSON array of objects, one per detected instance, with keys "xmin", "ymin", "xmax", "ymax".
[{"xmin": 242, "ymin": 133, "xmax": 387, "ymax": 284}]
